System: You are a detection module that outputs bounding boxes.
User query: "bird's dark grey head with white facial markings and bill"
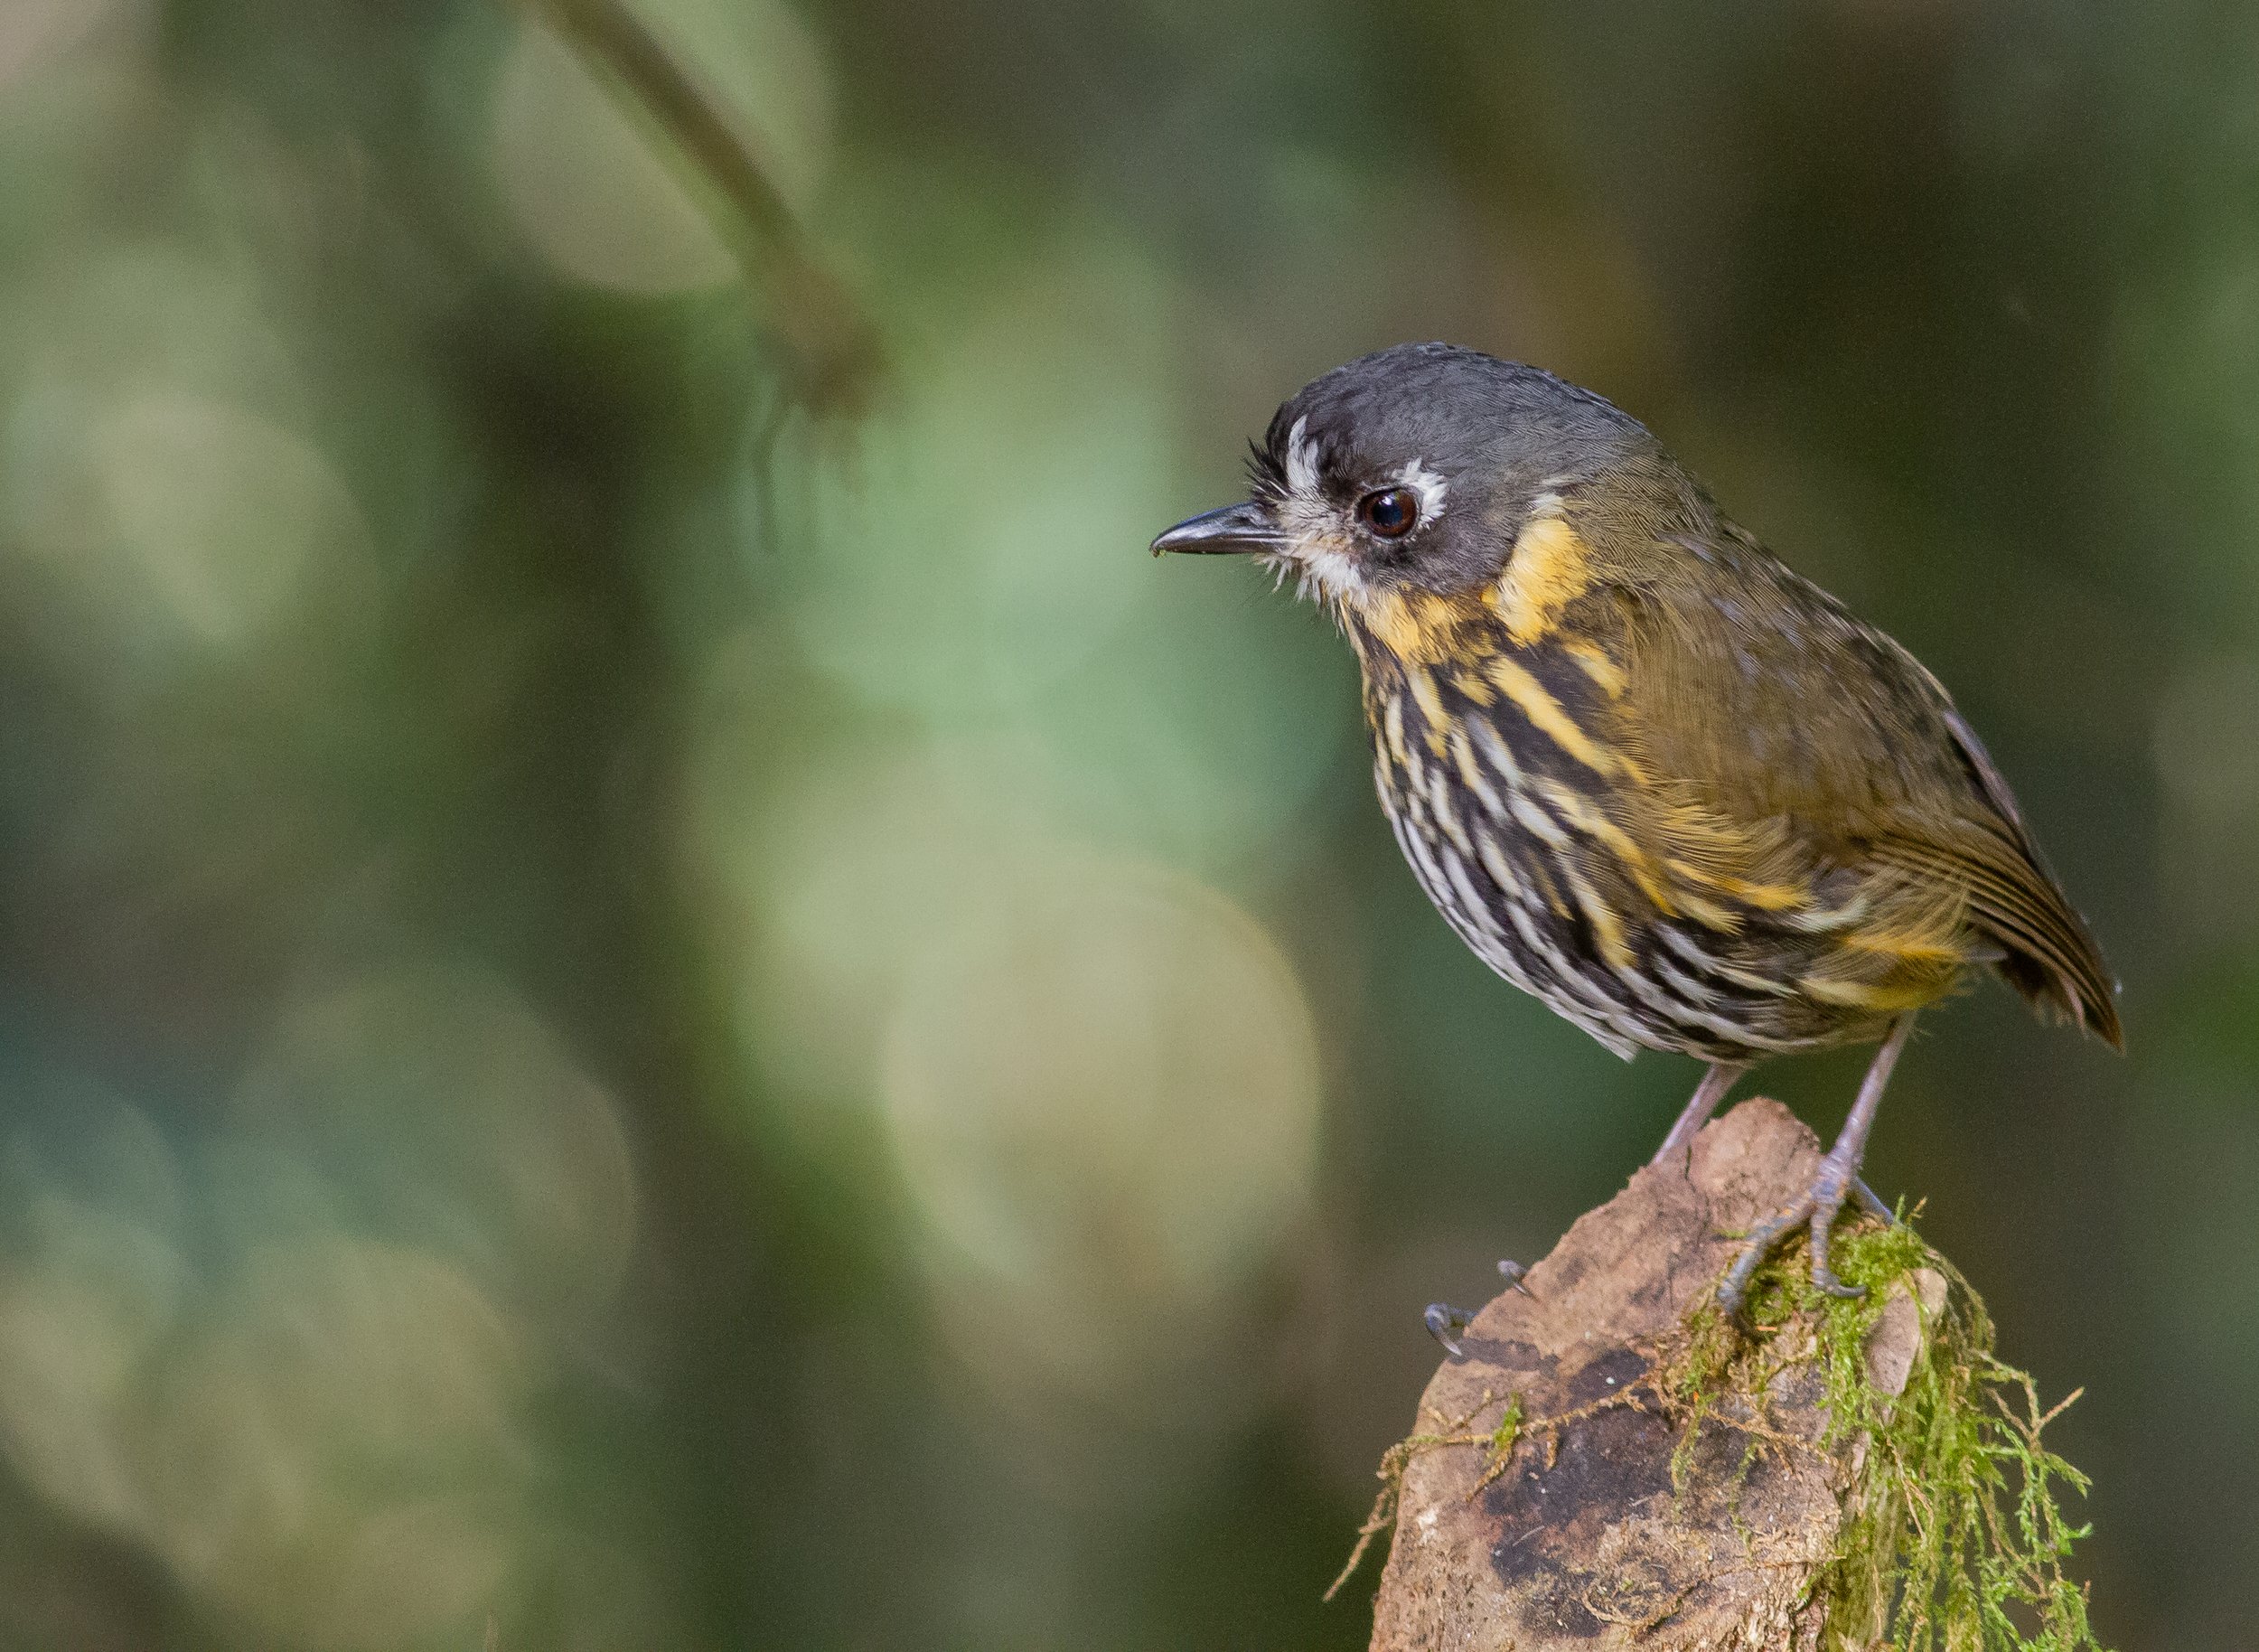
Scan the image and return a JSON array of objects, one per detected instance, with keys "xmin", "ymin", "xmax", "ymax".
[{"xmin": 1152, "ymin": 343, "xmax": 1654, "ymax": 615}]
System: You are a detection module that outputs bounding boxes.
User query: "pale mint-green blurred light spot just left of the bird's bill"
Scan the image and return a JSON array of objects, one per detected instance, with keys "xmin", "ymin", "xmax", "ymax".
[{"xmin": 789, "ymin": 229, "xmax": 1170, "ymax": 717}]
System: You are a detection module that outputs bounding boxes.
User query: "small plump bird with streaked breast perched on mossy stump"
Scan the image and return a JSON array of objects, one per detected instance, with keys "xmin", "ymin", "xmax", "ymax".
[{"xmin": 1152, "ymin": 343, "xmax": 2122, "ymax": 1309}]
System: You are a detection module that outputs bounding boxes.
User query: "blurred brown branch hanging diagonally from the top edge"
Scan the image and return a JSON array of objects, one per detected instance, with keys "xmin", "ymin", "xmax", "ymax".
[{"xmin": 518, "ymin": 0, "xmax": 884, "ymax": 411}]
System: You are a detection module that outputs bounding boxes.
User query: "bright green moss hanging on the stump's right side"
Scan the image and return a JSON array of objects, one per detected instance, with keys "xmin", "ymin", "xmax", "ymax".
[{"xmin": 1656, "ymin": 1223, "xmax": 2099, "ymax": 1652}]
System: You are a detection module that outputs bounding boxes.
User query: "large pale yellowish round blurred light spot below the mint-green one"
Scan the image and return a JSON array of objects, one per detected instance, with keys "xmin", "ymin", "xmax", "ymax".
[{"xmin": 884, "ymin": 849, "xmax": 1319, "ymax": 1396}]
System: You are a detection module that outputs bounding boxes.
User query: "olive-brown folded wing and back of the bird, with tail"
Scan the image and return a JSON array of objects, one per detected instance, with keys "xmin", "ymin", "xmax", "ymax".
[{"xmin": 1620, "ymin": 533, "xmax": 2123, "ymax": 1044}]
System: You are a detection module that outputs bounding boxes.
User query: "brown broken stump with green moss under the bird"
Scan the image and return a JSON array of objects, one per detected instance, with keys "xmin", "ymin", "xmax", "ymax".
[{"xmin": 1360, "ymin": 1101, "xmax": 2096, "ymax": 1652}]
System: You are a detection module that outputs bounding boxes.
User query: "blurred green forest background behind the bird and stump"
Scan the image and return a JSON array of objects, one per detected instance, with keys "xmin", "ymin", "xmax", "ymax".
[{"xmin": 0, "ymin": 0, "xmax": 2259, "ymax": 1652}]
